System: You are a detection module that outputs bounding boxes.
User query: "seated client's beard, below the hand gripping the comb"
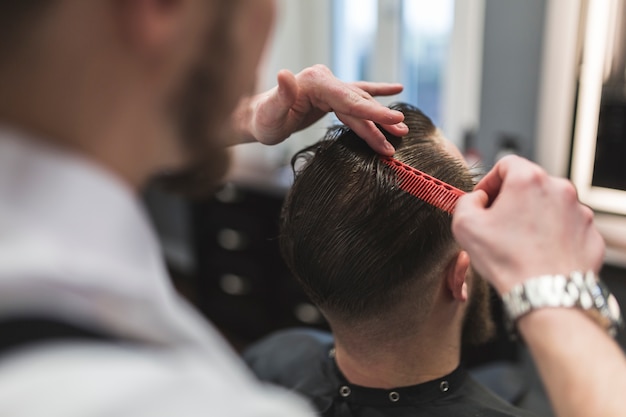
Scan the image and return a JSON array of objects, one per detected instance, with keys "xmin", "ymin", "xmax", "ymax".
[{"xmin": 462, "ymin": 268, "xmax": 496, "ymax": 346}]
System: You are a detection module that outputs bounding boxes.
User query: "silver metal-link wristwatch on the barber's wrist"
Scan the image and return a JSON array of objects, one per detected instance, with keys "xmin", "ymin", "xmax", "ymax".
[{"xmin": 502, "ymin": 271, "xmax": 624, "ymax": 336}]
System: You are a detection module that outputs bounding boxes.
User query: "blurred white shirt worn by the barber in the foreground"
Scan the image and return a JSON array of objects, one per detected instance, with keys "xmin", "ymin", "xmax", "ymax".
[{"xmin": 0, "ymin": 130, "xmax": 311, "ymax": 417}]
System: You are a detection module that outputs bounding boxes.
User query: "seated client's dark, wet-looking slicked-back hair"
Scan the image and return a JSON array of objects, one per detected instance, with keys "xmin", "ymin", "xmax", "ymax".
[{"xmin": 280, "ymin": 103, "xmax": 474, "ymax": 320}]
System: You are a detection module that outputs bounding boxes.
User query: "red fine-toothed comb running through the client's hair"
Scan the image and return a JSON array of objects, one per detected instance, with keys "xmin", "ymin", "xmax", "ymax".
[{"xmin": 381, "ymin": 157, "xmax": 465, "ymax": 214}]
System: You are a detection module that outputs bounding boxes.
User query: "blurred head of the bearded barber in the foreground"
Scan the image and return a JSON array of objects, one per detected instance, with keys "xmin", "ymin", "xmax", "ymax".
[{"xmin": 0, "ymin": 0, "xmax": 274, "ymax": 189}]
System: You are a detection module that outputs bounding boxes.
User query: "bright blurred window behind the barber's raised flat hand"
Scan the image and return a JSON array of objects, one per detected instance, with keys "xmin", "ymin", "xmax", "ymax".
[{"xmin": 332, "ymin": 0, "xmax": 454, "ymax": 125}]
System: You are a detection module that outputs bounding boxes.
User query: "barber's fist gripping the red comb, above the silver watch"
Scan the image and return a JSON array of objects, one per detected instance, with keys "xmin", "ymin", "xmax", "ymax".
[{"xmin": 452, "ymin": 156, "xmax": 604, "ymax": 294}]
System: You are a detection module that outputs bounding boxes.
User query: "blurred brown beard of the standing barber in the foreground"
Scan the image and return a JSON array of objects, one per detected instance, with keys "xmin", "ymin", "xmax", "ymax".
[{"xmin": 153, "ymin": 0, "xmax": 240, "ymax": 197}]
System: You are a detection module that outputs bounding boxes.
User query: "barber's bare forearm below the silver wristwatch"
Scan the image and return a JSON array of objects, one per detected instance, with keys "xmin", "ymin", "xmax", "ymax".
[{"xmin": 518, "ymin": 308, "xmax": 626, "ymax": 417}]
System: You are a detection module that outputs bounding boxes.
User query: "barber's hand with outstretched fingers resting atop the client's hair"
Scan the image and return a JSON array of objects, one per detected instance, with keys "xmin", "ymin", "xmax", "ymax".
[{"xmin": 233, "ymin": 65, "xmax": 408, "ymax": 155}]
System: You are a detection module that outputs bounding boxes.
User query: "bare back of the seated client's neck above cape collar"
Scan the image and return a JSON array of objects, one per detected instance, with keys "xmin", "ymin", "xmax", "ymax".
[{"xmin": 333, "ymin": 302, "xmax": 461, "ymax": 389}]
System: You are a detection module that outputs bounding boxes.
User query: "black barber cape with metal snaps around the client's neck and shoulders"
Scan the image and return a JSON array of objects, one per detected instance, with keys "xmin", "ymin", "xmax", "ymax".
[{"xmin": 244, "ymin": 329, "xmax": 535, "ymax": 417}]
